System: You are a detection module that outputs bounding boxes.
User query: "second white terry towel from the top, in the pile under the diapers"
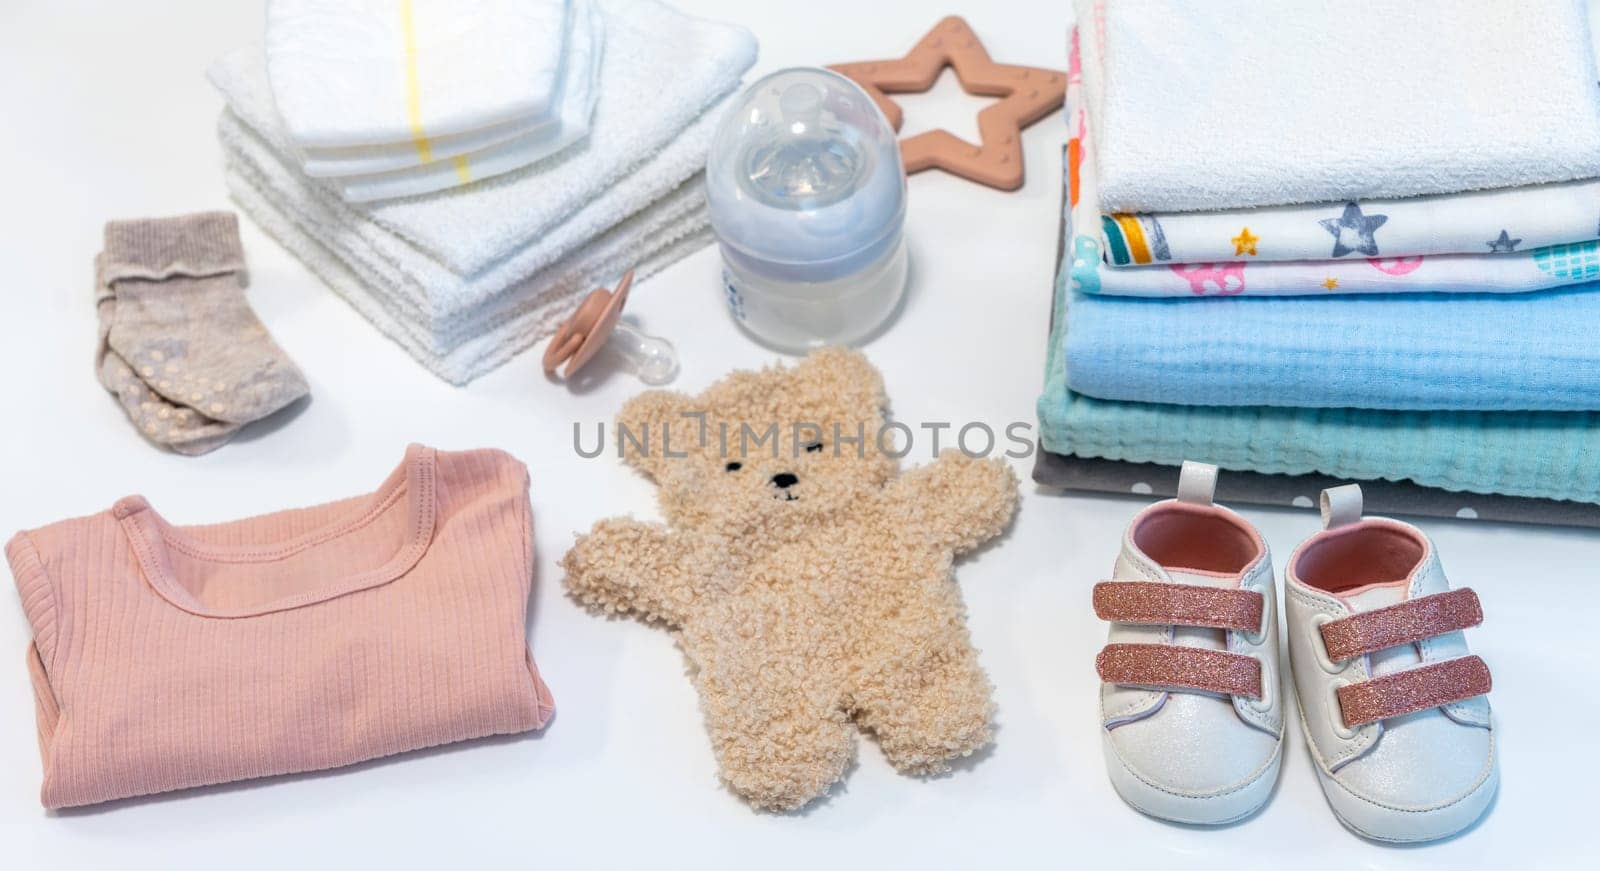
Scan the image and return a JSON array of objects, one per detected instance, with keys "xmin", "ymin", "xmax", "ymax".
[{"xmin": 218, "ymin": 98, "xmax": 731, "ymax": 334}]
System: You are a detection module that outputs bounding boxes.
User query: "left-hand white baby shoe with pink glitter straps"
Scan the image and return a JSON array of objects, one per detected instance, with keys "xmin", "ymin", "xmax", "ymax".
[{"xmin": 1094, "ymin": 463, "xmax": 1283, "ymax": 825}]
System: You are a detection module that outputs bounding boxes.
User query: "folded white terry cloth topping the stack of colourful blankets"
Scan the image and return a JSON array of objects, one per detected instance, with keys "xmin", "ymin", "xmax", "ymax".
[{"xmin": 1075, "ymin": 0, "xmax": 1600, "ymax": 211}]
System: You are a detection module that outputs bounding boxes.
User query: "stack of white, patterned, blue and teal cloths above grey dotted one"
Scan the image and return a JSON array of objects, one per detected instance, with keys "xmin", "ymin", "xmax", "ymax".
[{"xmin": 1038, "ymin": 0, "xmax": 1600, "ymax": 503}]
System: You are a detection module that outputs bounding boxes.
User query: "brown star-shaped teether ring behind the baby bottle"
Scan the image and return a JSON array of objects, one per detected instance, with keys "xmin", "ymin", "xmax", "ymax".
[{"xmin": 829, "ymin": 16, "xmax": 1067, "ymax": 191}]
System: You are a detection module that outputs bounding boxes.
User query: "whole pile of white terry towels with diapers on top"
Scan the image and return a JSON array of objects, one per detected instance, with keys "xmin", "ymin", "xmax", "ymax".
[{"xmin": 211, "ymin": 0, "xmax": 755, "ymax": 384}]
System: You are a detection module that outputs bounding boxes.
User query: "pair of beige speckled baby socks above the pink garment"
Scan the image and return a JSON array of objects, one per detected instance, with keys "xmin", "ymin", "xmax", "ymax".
[{"xmin": 99, "ymin": 211, "xmax": 309, "ymax": 453}]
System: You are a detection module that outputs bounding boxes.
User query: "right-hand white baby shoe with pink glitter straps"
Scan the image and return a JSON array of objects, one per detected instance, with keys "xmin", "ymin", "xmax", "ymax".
[{"xmin": 1285, "ymin": 484, "xmax": 1499, "ymax": 842}]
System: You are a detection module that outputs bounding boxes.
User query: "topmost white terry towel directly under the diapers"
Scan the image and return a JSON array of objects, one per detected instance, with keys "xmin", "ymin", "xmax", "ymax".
[{"xmin": 211, "ymin": 0, "xmax": 755, "ymax": 275}]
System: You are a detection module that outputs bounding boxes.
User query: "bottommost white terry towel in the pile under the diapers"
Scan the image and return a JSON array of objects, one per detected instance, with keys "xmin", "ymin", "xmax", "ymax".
[{"xmin": 226, "ymin": 170, "xmax": 710, "ymax": 384}]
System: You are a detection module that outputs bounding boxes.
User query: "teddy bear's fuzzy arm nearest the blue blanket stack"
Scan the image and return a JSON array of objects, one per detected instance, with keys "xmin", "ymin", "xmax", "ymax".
[{"xmin": 891, "ymin": 450, "xmax": 1016, "ymax": 554}]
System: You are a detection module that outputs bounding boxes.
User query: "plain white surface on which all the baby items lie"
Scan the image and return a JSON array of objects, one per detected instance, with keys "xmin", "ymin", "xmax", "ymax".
[{"xmin": 0, "ymin": 0, "xmax": 1600, "ymax": 869}]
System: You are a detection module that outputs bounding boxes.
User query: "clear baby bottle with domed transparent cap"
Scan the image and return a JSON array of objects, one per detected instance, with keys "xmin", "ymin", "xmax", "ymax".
[{"xmin": 706, "ymin": 67, "xmax": 907, "ymax": 352}]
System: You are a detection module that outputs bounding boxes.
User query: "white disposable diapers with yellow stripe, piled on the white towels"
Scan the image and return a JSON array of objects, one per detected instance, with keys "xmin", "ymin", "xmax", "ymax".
[{"xmin": 264, "ymin": 0, "xmax": 605, "ymax": 202}]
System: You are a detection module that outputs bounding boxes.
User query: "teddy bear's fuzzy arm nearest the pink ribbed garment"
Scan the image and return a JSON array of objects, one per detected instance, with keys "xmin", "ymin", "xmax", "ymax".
[{"xmin": 562, "ymin": 517, "xmax": 715, "ymax": 626}]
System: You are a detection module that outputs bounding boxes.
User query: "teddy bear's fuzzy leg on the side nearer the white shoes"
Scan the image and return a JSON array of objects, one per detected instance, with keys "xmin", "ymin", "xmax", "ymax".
[{"xmin": 856, "ymin": 639, "xmax": 994, "ymax": 773}]
